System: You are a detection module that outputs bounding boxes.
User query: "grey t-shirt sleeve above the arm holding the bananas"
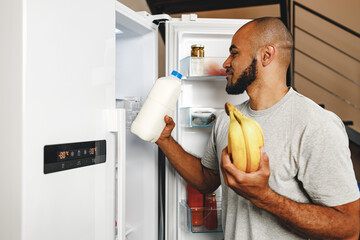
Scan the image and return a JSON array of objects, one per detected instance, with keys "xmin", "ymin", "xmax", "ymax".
[{"xmin": 298, "ymin": 113, "xmax": 360, "ymax": 206}]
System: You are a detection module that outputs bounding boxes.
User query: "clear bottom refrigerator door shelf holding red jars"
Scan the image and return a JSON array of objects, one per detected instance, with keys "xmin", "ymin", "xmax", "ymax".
[{"xmin": 179, "ymin": 200, "xmax": 222, "ymax": 233}]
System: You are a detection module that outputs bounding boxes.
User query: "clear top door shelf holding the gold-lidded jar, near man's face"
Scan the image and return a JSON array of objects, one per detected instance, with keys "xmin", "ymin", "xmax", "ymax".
[{"xmin": 180, "ymin": 57, "xmax": 226, "ymax": 80}]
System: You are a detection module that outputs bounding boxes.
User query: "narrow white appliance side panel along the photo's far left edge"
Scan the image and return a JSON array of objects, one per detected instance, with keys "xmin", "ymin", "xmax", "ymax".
[{"xmin": 0, "ymin": 0, "xmax": 24, "ymax": 240}]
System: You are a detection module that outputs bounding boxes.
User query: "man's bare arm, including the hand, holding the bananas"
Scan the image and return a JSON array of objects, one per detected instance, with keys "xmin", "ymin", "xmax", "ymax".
[{"xmin": 221, "ymin": 148, "xmax": 359, "ymax": 239}]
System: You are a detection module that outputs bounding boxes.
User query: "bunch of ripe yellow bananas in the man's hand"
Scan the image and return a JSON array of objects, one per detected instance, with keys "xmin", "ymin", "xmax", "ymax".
[{"xmin": 225, "ymin": 103, "xmax": 264, "ymax": 172}]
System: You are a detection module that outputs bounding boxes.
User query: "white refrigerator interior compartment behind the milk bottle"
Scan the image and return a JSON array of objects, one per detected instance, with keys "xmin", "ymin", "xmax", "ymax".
[{"xmin": 114, "ymin": 3, "xmax": 158, "ymax": 240}]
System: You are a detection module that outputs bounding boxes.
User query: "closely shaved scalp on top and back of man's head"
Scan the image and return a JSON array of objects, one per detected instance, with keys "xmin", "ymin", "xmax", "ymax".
[{"xmin": 237, "ymin": 17, "xmax": 293, "ymax": 68}]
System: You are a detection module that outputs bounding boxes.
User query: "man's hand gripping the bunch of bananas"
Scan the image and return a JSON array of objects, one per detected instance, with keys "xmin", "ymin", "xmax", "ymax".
[{"xmin": 220, "ymin": 146, "xmax": 272, "ymax": 205}]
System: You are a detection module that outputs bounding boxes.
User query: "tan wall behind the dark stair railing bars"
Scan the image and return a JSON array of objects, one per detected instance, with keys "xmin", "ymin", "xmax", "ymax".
[{"xmin": 294, "ymin": 0, "xmax": 360, "ymax": 132}]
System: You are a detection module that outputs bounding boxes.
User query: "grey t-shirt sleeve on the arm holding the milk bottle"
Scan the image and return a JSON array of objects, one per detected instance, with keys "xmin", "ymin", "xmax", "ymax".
[{"xmin": 201, "ymin": 121, "xmax": 219, "ymax": 170}]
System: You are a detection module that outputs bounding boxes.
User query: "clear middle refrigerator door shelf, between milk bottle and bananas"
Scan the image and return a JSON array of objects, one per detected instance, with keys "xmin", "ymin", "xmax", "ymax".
[{"xmin": 180, "ymin": 107, "xmax": 221, "ymax": 127}]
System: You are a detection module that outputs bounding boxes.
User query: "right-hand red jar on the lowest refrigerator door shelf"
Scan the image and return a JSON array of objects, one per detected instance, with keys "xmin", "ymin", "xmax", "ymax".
[{"xmin": 204, "ymin": 193, "xmax": 218, "ymax": 230}]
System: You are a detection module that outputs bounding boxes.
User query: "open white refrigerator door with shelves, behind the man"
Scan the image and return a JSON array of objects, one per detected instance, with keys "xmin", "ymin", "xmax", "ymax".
[{"xmin": 166, "ymin": 14, "xmax": 249, "ymax": 240}]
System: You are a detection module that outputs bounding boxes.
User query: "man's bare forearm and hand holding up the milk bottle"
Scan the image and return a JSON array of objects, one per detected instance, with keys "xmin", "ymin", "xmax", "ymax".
[{"xmin": 156, "ymin": 116, "xmax": 220, "ymax": 193}]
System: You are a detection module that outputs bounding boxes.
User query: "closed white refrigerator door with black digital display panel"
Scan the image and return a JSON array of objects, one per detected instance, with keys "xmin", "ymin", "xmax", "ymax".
[{"xmin": 0, "ymin": 0, "xmax": 115, "ymax": 240}]
